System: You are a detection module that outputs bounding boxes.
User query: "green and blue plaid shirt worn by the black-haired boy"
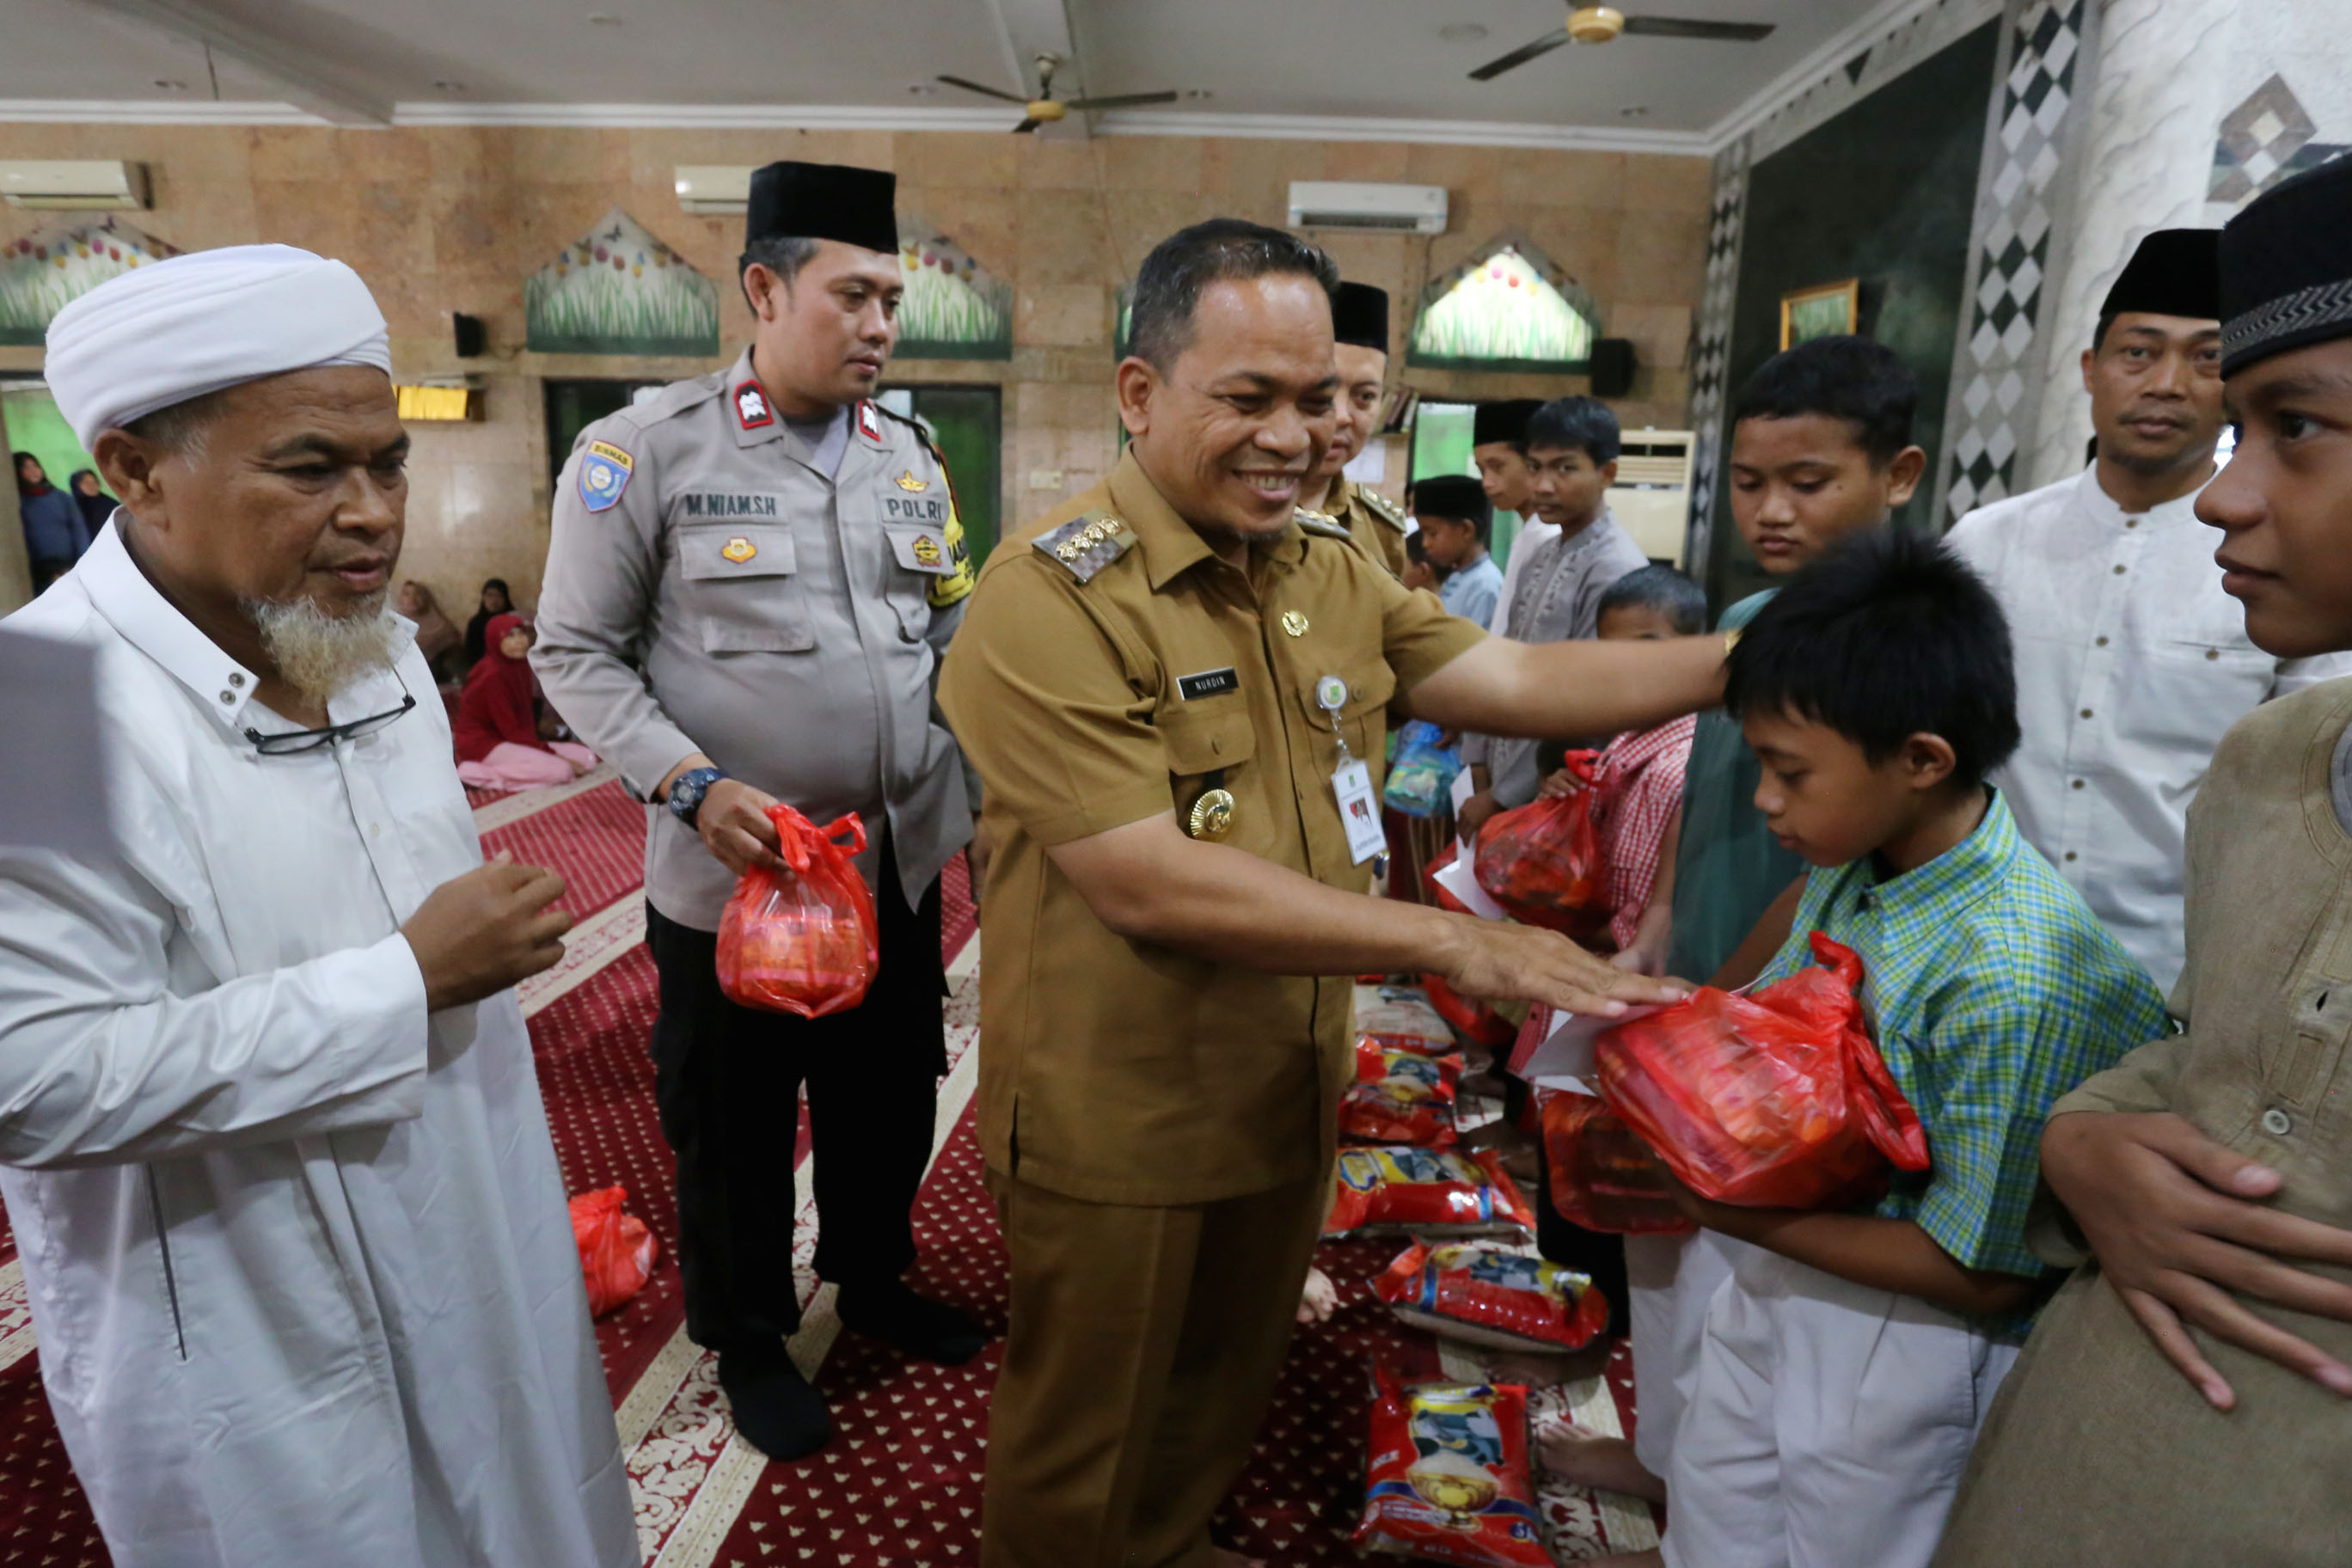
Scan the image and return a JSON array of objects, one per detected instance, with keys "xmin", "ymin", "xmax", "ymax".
[{"xmin": 1761, "ymin": 793, "xmax": 2169, "ymax": 1277}]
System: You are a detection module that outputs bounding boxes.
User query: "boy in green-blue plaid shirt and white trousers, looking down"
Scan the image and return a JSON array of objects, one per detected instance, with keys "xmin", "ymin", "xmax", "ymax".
[{"xmin": 1665, "ymin": 531, "xmax": 2164, "ymax": 1568}]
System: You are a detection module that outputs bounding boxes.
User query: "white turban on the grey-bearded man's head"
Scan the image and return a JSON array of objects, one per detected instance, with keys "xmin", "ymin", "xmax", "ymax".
[{"xmin": 42, "ymin": 244, "xmax": 393, "ymax": 451}]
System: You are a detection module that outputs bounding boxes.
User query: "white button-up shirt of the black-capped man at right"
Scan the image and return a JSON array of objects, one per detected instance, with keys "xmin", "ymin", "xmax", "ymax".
[{"xmin": 1950, "ymin": 465, "xmax": 2352, "ymax": 992}]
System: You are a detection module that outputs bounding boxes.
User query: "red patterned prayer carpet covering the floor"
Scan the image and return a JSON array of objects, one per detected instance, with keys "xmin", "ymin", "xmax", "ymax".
[{"xmin": 0, "ymin": 769, "xmax": 1653, "ymax": 1568}]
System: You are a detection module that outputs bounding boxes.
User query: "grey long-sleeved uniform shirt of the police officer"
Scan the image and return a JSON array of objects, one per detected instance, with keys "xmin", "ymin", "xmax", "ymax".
[{"xmin": 531, "ymin": 350, "xmax": 974, "ymax": 931}]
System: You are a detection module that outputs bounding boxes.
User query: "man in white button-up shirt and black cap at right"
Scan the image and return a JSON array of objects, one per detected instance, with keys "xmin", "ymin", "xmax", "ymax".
[{"xmin": 1950, "ymin": 228, "xmax": 2352, "ymax": 989}]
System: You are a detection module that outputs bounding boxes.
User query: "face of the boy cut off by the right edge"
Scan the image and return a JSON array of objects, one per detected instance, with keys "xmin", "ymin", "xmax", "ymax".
[{"xmin": 2196, "ymin": 339, "xmax": 2352, "ymax": 658}]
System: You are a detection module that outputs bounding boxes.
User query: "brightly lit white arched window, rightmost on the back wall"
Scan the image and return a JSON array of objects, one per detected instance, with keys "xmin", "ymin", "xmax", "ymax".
[{"xmin": 1404, "ymin": 240, "xmax": 1599, "ymax": 371}]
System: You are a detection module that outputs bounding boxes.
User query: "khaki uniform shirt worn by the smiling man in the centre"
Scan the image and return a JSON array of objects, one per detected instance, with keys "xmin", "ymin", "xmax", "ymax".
[{"xmin": 939, "ymin": 454, "xmax": 1486, "ymax": 1204}]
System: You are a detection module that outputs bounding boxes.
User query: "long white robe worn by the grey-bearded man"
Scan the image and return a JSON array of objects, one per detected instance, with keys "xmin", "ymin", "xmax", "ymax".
[{"xmin": 0, "ymin": 527, "xmax": 637, "ymax": 1568}]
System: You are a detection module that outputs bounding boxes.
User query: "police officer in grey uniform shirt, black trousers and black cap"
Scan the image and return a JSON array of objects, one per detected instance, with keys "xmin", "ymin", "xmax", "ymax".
[{"xmin": 531, "ymin": 162, "xmax": 983, "ymax": 1457}]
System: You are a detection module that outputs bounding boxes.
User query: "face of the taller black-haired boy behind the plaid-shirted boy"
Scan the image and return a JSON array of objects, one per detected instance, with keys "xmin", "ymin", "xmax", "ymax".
[{"xmin": 1729, "ymin": 413, "xmax": 1926, "ymax": 576}]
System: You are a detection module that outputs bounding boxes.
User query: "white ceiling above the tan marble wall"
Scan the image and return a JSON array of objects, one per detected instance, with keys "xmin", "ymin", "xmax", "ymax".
[{"xmin": 0, "ymin": 0, "xmax": 1891, "ymax": 144}]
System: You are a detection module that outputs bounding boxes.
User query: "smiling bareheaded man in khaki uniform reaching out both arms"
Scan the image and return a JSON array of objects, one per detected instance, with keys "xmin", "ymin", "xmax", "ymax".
[{"xmin": 940, "ymin": 218, "xmax": 1722, "ymax": 1568}]
